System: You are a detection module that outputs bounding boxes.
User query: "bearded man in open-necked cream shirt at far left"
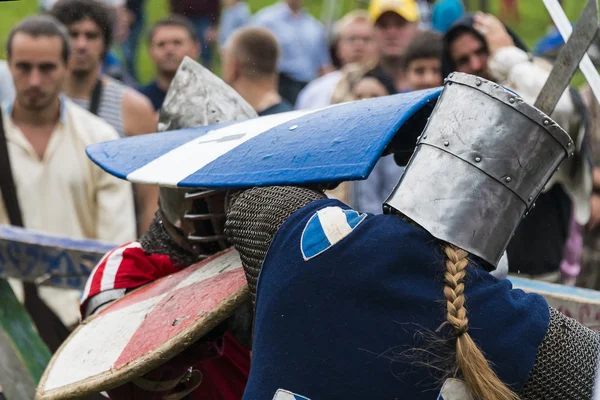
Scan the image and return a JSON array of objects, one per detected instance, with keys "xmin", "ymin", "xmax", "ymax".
[{"xmin": 0, "ymin": 16, "xmax": 135, "ymax": 351}]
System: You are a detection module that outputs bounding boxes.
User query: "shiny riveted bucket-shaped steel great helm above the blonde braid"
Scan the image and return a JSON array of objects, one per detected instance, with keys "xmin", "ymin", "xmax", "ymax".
[{"xmin": 384, "ymin": 73, "xmax": 574, "ymax": 266}]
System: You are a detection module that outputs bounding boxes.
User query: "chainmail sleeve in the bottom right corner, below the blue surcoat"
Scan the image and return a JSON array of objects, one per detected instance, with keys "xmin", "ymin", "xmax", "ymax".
[{"xmin": 519, "ymin": 307, "xmax": 600, "ymax": 400}]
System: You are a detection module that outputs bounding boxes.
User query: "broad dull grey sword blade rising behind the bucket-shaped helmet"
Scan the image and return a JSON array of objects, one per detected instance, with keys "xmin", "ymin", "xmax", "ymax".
[{"xmin": 534, "ymin": 0, "xmax": 599, "ymax": 115}]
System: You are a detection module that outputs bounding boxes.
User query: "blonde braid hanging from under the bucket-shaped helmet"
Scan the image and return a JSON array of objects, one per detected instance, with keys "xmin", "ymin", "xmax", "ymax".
[{"xmin": 444, "ymin": 245, "xmax": 519, "ymax": 400}]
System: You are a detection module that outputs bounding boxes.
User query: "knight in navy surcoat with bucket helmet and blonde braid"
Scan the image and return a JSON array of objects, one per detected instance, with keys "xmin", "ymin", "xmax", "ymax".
[{"xmin": 226, "ymin": 74, "xmax": 600, "ymax": 400}]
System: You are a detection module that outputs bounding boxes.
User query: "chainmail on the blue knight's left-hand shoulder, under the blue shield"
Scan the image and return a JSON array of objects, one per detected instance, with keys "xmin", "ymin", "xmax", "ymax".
[{"xmin": 225, "ymin": 186, "xmax": 326, "ymax": 303}]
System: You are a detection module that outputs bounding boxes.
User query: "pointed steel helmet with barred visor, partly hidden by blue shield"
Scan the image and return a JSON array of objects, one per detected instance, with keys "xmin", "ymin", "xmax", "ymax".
[{"xmin": 158, "ymin": 57, "xmax": 257, "ymax": 260}]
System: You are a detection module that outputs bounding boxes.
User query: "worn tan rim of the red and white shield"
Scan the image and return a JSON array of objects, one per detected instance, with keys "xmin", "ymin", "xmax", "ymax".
[{"xmin": 36, "ymin": 285, "xmax": 250, "ymax": 400}]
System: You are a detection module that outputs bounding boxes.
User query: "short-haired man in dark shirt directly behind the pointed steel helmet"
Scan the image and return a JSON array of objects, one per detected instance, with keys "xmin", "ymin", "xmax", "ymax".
[{"xmin": 139, "ymin": 15, "xmax": 200, "ymax": 111}]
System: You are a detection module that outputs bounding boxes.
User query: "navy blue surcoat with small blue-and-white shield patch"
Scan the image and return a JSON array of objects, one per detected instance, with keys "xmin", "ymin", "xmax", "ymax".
[{"xmin": 244, "ymin": 199, "xmax": 550, "ymax": 400}]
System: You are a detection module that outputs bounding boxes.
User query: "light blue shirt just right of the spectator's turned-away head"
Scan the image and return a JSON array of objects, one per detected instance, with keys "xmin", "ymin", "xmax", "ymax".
[{"xmin": 250, "ymin": 2, "xmax": 331, "ymax": 82}]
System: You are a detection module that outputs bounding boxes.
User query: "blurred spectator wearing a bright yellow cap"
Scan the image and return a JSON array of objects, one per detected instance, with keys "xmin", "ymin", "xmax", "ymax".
[{"xmin": 369, "ymin": 0, "xmax": 420, "ymax": 92}]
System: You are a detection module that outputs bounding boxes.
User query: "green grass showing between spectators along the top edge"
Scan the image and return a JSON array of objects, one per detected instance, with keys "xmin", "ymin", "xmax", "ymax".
[{"xmin": 0, "ymin": 0, "xmax": 585, "ymax": 84}]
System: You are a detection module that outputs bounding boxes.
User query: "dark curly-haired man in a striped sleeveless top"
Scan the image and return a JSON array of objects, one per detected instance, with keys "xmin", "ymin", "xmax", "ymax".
[{"xmin": 50, "ymin": 0, "xmax": 158, "ymax": 233}]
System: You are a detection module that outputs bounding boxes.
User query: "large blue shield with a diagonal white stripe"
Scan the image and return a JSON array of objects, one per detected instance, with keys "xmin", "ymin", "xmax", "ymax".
[{"xmin": 87, "ymin": 88, "xmax": 442, "ymax": 188}]
